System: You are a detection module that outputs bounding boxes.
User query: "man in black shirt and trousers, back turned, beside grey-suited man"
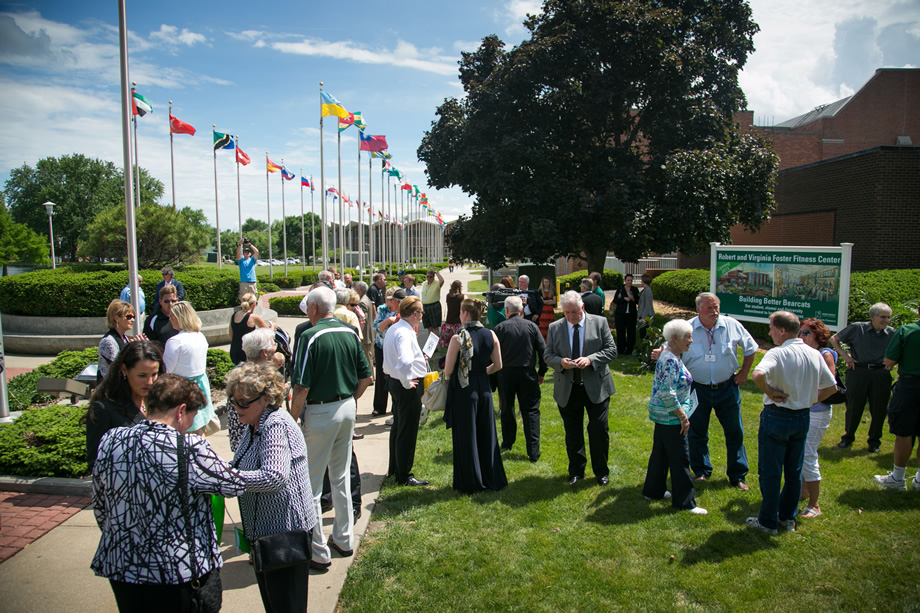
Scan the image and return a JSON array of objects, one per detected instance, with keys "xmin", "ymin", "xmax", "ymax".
[{"xmin": 495, "ymin": 296, "xmax": 547, "ymax": 462}]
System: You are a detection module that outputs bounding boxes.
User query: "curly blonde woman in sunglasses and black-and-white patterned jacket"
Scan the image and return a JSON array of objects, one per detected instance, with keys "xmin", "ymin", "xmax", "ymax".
[{"xmin": 226, "ymin": 362, "xmax": 316, "ymax": 613}]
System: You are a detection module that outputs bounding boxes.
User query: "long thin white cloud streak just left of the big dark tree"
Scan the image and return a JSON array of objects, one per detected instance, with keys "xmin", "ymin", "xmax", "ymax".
[{"xmin": 271, "ymin": 38, "xmax": 457, "ymax": 75}]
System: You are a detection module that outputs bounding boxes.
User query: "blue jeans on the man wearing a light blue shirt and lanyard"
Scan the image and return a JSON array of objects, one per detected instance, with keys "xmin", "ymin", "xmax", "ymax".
[{"xmin": 687, "ymin": 377, "xmax": 748, "ymax": 483}]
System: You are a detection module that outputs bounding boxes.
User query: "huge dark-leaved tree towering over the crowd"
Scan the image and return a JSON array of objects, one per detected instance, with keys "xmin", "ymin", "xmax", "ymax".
[{"xmin": 418, "ymin": 0, "xmax": 777, "ymax": 269}]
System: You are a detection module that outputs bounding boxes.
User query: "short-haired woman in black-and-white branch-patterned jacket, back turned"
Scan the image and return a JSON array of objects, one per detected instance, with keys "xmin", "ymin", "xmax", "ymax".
[{"xmin": 92, "ymin": 374, "xmax": 244, "ymax": 611}]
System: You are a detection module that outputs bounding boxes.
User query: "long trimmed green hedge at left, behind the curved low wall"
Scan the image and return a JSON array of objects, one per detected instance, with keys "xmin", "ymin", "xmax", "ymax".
[{"xmin": 0, "ymin": 267, "xmax": 239, "ymax": 317}]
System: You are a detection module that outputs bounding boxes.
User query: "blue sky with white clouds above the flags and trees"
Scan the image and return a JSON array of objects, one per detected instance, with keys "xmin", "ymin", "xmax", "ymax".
[{"xmin": 0, "ymin": 0, "xmax": 920, "ymax": 229}]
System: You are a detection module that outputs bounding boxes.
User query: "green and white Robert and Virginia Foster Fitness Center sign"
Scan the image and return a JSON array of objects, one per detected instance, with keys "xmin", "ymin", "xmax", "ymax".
[{"xmin": 709, "ymin": 243, "xmax": 853, "ymax": 331}]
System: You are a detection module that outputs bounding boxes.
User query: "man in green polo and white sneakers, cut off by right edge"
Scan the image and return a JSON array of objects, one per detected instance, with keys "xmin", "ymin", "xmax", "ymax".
[{"xmin": 875, "ymin": 308, "xmax": 920, "ymax": 492}]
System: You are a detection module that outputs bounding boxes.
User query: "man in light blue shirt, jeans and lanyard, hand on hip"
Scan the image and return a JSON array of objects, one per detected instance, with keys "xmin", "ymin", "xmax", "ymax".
[{"xmin": 652, "ymin": 292, "xmax": 757, "ymax": 492}]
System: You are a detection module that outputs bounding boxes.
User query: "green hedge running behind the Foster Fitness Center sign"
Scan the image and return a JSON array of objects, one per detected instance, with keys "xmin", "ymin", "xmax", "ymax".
[{"xmin": 652, "ymin": 268, "xmax": 920, "ymax": 327}]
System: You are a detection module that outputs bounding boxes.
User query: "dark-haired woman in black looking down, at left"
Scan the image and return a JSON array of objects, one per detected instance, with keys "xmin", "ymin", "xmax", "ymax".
[{"xmin": 85, "ymin": 342, "xmax": 165, "ymax": 472}]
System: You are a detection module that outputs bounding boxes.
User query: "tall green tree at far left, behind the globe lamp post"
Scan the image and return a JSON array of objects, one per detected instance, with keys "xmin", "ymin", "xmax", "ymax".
[{"xmin": 4, "ymin": 153, "xmax": 163, "ymax": 259}]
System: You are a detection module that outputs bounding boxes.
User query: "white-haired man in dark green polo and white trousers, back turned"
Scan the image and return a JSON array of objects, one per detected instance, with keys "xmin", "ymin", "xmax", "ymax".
[{"xmin": 291, "ymin": 287, "xmax": 371, "ymax": 568}]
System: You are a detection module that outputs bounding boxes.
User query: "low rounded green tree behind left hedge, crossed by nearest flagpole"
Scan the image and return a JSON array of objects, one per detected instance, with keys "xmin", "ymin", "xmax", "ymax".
[{"xmin": 80, "ymin": 203, "xmax": 213, "ymax": 268}]
